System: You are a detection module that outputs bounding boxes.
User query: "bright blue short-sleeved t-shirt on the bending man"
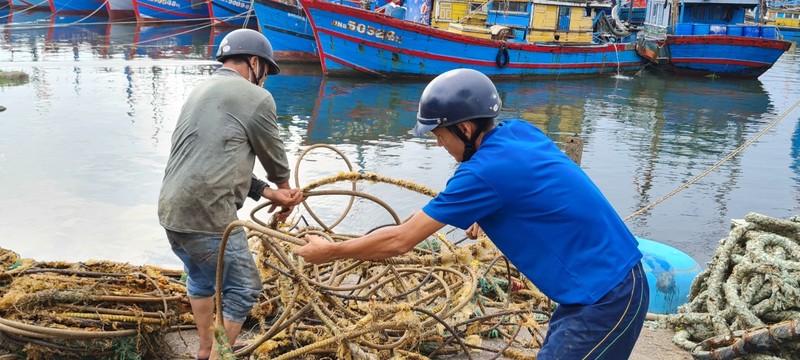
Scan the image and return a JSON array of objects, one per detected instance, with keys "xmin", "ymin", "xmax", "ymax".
[{"xmin": 422, "ymin": 120, "xmax": 642, "ymax": 305}]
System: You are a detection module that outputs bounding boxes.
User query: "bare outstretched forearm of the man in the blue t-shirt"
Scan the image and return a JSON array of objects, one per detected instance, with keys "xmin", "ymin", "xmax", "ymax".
[{"xmin": 295, "ymin": 211, "xmax": 445, "ymax": 264}]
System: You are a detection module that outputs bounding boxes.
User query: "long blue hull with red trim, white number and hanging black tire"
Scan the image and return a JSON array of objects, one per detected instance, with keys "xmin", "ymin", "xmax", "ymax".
[{"xmin": 301, "ymin": 0, "xmax": 643, "ymax": 77}]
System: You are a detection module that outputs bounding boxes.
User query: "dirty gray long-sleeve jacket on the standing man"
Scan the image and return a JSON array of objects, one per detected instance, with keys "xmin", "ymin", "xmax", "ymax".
[{"xmin": 158, "ymin": 67, "xmax": 290, "ymax": 235}]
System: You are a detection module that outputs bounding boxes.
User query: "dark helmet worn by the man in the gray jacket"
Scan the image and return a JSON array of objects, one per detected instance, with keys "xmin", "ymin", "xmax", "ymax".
[{"xmin": 217, "ymin": 29, "xmax": 281, "ymax": 75}]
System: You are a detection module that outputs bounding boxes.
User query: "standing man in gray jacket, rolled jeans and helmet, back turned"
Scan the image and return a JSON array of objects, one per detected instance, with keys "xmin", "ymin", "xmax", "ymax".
[{"xmin": 158, "ymin": 29, "xmax": 303, "ymax": 359}]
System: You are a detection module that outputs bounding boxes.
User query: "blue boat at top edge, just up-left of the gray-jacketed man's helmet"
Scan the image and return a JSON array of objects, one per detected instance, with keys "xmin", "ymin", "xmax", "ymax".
[{"xmin": 130, "ymin": 0, "xmax": 209, "ymax": 22}]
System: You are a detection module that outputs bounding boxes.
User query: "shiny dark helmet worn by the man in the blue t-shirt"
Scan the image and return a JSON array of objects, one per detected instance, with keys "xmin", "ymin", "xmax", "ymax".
[{"xmin": 414, "ymin": 69, "xmax": 502, "ymax": 136}]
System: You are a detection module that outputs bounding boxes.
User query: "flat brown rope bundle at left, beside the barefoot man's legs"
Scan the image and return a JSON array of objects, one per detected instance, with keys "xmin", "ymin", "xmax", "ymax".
[{"xmin": 0, "ymin": 249, "xmax": 191, "ymax": 359}]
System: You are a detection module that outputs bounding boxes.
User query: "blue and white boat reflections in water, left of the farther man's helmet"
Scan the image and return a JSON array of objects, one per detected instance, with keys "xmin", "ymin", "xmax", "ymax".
[{"xmin": 0, "ymin": 10, "xmax": 234, "ymax": 62}]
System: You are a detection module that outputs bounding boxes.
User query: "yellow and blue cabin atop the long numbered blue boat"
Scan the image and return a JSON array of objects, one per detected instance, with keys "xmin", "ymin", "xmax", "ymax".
[{"xmin": 431, "ymin": 0, "xmax": 630, "ymax": 44}]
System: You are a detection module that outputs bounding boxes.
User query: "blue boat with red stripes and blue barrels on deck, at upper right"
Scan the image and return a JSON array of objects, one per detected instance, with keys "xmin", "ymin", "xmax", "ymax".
[{"xmin": 637, "ymin": 0, "xmax": 791, "ymax": 78}]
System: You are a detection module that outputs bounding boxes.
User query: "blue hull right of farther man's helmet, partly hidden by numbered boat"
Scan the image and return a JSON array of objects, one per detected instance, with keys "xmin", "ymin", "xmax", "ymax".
[{"xmin": 253, "ymin": 0, "xmax": 319, "ymax": 62}]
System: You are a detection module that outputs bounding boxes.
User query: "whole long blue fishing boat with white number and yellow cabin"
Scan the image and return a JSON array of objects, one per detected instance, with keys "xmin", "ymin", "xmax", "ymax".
[{"xmin": 300, "ymin": 0, "xmax": 643, "ymax": 78}]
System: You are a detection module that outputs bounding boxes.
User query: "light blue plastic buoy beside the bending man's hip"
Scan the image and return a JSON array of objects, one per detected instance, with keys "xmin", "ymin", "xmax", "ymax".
[{"xmin": 636, "ymin": 237, "xmax": 702, "ymax": 314}]
